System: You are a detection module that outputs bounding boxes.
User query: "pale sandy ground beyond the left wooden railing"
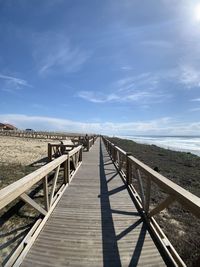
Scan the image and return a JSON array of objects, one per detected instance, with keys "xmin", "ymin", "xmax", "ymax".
[{"xmin": 0, "ymin": 136, "xmax": 72, "ymax": 189}]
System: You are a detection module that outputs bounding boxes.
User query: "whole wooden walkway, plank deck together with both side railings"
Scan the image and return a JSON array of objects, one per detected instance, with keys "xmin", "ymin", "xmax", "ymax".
[{"xmin": 0, "ymin": 138, "xmax": 200, "ymax": 267}]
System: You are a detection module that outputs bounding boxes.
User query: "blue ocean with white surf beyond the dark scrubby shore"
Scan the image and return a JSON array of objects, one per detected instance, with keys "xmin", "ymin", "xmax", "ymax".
[{"xmin": 118, "ymin": 135, "xmax": 200, "ymax": 156}]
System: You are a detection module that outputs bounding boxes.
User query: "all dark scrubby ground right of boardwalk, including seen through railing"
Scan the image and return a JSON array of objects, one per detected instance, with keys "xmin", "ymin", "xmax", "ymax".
[{"xmin": 109, "ymin": 138, "xmax": 200, "ymax": 266}]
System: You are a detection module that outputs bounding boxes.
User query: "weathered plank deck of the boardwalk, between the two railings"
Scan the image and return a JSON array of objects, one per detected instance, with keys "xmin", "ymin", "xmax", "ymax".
[{"xmin": 21, "ymin": 140, "xmax": 165, "ymax": 267}]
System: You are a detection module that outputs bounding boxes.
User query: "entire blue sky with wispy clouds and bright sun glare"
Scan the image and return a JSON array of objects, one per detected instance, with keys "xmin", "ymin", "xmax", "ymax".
[{"xmin": 0, "ymin": 0, "xmax": 200, "ymax": 135}]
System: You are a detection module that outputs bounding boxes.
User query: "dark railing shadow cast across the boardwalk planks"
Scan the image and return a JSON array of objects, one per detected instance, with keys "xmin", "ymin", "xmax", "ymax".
[{"xmin": 99, "ymin": 142, "xmax": 146, "ymax": 267}]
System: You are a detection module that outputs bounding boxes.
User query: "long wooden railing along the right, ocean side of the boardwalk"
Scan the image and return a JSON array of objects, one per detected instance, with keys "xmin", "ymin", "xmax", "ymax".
[{"xmin": 103, "ymin": 137, "xmax": 200, "ymax": 266}]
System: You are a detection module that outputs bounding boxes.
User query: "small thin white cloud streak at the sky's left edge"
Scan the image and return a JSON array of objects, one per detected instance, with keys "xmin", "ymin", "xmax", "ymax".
[{"xmin": 0, "ymin": 73, "xmax": 32, "ymax": 92}]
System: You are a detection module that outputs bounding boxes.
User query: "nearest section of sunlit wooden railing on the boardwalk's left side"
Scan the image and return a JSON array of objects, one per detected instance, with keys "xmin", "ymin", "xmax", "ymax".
[{"xmin": 0, "ymin": 146, "xmax": 82, "ymax": 267}]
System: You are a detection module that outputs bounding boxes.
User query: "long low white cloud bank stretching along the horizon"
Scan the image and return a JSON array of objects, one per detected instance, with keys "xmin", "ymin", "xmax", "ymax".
[{"xmin": 0, "ymin": 114, "xmax": 200, "ymax": 135}]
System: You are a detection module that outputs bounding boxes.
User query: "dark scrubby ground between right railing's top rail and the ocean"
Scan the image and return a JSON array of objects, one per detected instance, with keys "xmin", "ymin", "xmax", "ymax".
[{"xmin": 109, "ymin": 137, "xmax": 200, "ymax": 197}]
